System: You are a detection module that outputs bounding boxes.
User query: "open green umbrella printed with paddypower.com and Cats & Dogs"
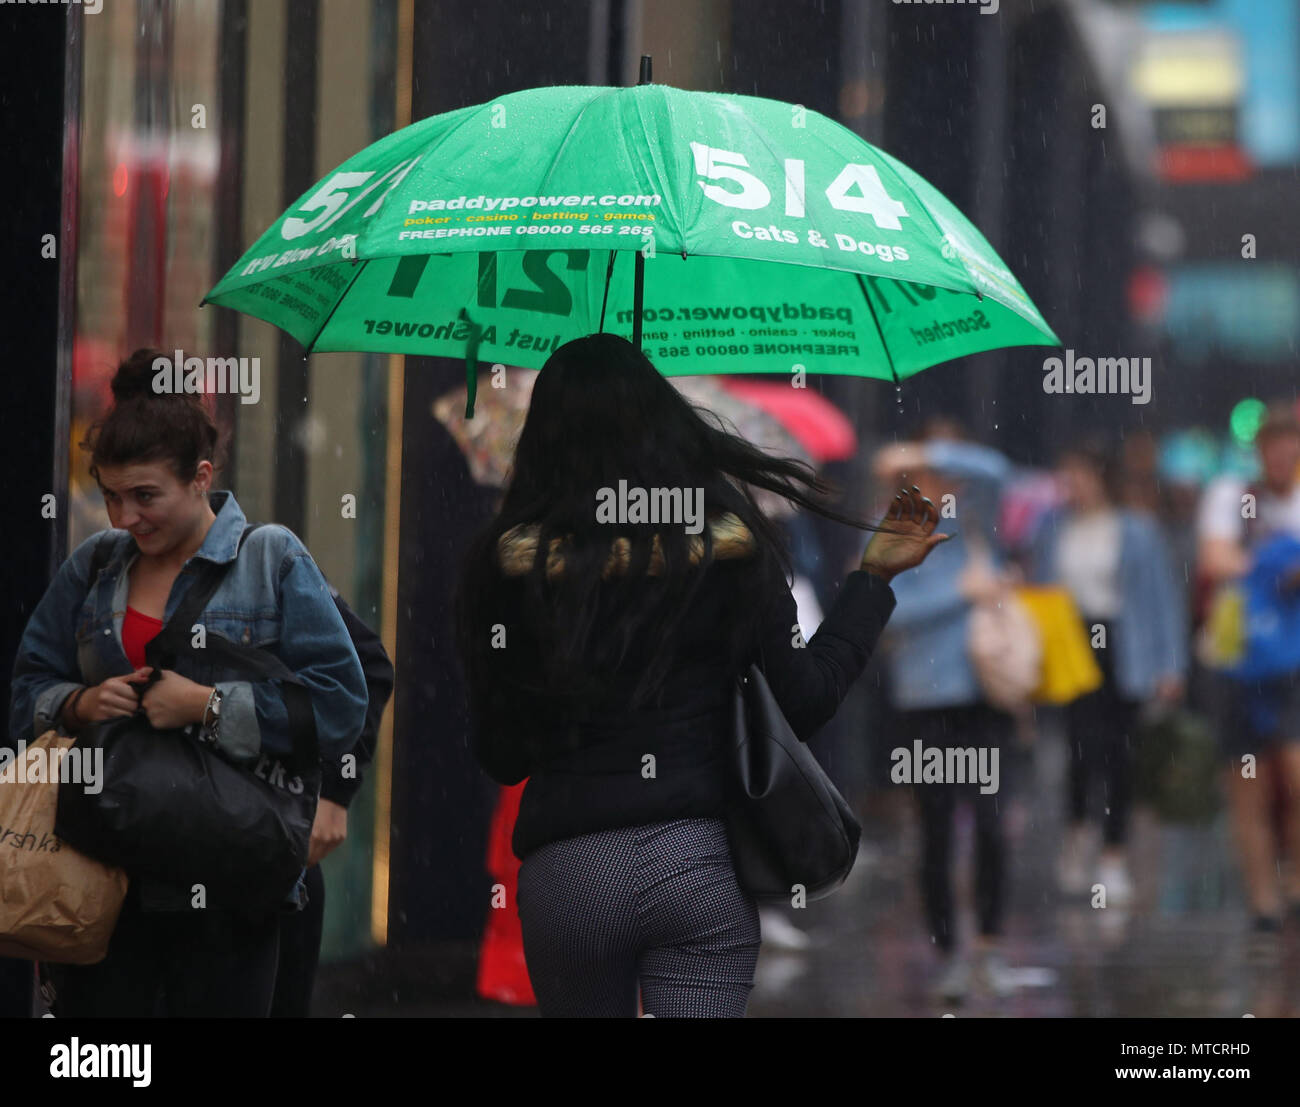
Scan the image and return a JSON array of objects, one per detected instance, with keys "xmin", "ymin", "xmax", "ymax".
[{"xmin": 204, "ymin": 72, "xmax": 1060, "ymax": 417}]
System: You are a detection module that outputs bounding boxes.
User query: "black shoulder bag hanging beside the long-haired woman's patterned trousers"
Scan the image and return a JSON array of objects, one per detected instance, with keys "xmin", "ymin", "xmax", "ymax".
[{"xmin": 727, "ymin": 644, "xmax": 862, "ymax": 903}]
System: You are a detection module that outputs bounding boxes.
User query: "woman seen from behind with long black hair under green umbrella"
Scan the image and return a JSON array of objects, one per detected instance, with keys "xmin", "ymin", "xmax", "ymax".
[{"xmin": 456, "ymin": 334, "xmax": 944, "ymax": 1016}]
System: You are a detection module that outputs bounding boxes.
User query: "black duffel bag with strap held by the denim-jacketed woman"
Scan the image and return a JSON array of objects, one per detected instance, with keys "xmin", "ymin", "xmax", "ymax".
[{"xmin": 55, "ymin": 528, "xmax": 321, "ymax": 912}]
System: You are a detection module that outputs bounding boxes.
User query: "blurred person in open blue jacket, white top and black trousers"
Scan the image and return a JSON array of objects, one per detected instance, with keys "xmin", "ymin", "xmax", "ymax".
[{"xmin": 1028, "ymin": 443, "xmax": 1188, "ymax": 906}]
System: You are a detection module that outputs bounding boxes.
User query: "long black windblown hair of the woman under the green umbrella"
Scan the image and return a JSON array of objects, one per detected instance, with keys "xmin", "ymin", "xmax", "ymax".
[{"xmin": 454, "ymin": 334, "xmax": 875, "ymax": 707}]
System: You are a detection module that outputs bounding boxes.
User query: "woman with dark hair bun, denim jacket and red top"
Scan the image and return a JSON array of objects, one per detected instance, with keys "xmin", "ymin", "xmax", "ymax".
[{"xmin": 9, "ymin": 350, "xmax": 367, "ymax": 1016}]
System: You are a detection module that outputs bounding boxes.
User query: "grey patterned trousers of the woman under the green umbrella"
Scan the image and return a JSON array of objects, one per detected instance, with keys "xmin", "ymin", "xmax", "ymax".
[{"xmin": 519, "ymin": 819, "xmax": 759, "ymax": 1019}]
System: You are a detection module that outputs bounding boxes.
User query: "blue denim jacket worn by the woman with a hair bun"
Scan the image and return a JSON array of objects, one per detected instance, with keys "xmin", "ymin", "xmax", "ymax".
[{"xmin": 8, "ymin": 491, "xmax": 368, "ymax": 908}]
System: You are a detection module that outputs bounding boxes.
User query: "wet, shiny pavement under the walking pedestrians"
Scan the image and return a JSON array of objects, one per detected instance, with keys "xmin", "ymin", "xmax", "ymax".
[{"xmin": 315, "ymin": 734, "xmax": 1300, "ymax": 1019}]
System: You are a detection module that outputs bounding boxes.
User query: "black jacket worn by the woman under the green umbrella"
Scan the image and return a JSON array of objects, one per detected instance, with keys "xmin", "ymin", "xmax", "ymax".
[{"xmin": 472, "ymin": 548, "xmax": 894, "ymax": 858}]
